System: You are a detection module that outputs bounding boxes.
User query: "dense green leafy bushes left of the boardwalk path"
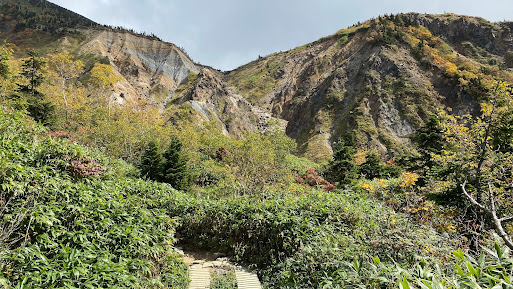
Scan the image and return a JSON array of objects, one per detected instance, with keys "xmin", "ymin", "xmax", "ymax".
[{"xmin": 0, "ymin": 109, "xmax": 188, "ymax": 288}]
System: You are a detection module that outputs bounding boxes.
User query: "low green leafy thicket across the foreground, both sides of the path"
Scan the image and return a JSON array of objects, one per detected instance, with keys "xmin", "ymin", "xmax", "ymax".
[{"xmin": 0, "ymin": 100, "xmax": 512, "ymax": 288}]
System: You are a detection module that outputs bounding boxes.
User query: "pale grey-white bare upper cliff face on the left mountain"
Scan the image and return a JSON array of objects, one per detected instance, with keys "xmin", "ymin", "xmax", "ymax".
[{"xmin": 80, "ymin": 30, "xmax": 201, "ymax": 106}]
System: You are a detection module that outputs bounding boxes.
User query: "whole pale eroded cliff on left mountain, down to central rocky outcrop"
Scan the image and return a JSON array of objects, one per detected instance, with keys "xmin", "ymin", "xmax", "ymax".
[{"xmin": 74, "ymin": 30, "xmax": 285, "ymax": 137}]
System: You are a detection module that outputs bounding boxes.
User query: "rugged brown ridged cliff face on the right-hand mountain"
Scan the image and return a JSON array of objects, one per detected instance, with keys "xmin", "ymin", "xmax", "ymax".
[{"xmin": 226, "ymin": 28, "xmax": 432, "ymax": 161}]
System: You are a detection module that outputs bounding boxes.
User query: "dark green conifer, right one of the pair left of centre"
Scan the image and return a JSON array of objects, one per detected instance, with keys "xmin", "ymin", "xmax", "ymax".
[{"xmin": 161, "ymin": 135, "xmax": 192, "ymax": 190}]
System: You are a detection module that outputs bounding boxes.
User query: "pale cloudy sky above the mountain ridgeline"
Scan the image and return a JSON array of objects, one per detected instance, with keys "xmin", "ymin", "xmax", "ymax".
[{"xmin": 50, "ymin": 0, "xmax": 513, "ymax": 70}]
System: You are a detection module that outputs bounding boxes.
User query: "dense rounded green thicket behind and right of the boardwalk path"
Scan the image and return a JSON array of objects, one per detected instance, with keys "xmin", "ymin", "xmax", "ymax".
[{"xmin": 169, "ymin": 191, "xmax": 451, "ymax": 288}]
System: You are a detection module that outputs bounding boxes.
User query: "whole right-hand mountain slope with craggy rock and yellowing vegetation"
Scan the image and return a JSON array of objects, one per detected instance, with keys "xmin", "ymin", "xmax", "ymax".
[{"xmin": 225, "ymin": 13, "xmax": 513, "ymax": 160}]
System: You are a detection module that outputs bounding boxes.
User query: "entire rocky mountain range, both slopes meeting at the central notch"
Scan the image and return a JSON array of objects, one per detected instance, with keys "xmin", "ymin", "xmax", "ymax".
[{"xmin": 0, "ymin": 0, "xmax": 513, "ymax": 160}]
